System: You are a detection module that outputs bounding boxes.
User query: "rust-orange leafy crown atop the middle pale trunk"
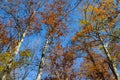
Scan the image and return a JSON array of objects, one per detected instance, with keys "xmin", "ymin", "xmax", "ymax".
[{"xmin": 40, "ymin": 1, "xmax": 67, "ymax": 36}]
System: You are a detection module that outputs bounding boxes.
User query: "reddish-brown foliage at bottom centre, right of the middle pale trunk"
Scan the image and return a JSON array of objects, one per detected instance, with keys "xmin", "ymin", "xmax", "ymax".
[{"xmin": 44, "ymin": 43, "xmax": 77, "ymax": 80}]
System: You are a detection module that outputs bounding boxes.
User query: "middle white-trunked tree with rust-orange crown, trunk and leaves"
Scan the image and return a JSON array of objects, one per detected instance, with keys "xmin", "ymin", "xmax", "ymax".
[{"xmin": 37, "ymin": 0, "xmax": 81, "ymax": 80}]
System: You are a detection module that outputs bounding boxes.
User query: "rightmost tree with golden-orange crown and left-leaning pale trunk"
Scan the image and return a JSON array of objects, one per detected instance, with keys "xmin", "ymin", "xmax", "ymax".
[{"xmin": 72, "ymin": 0, "xmax": 119, "ymax": 80}]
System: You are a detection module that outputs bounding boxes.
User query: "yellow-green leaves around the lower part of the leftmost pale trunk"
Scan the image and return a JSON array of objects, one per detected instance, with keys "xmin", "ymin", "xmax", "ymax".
[{"xmin": 0, "ymin": 50, "xmax": 32, "ymax": 77}]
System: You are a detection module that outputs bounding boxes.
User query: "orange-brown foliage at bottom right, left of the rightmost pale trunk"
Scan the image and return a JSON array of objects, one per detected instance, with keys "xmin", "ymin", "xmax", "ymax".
[{"xmin": 79, "ymin": 53, "xmax": 115, "ymax": 80}]
